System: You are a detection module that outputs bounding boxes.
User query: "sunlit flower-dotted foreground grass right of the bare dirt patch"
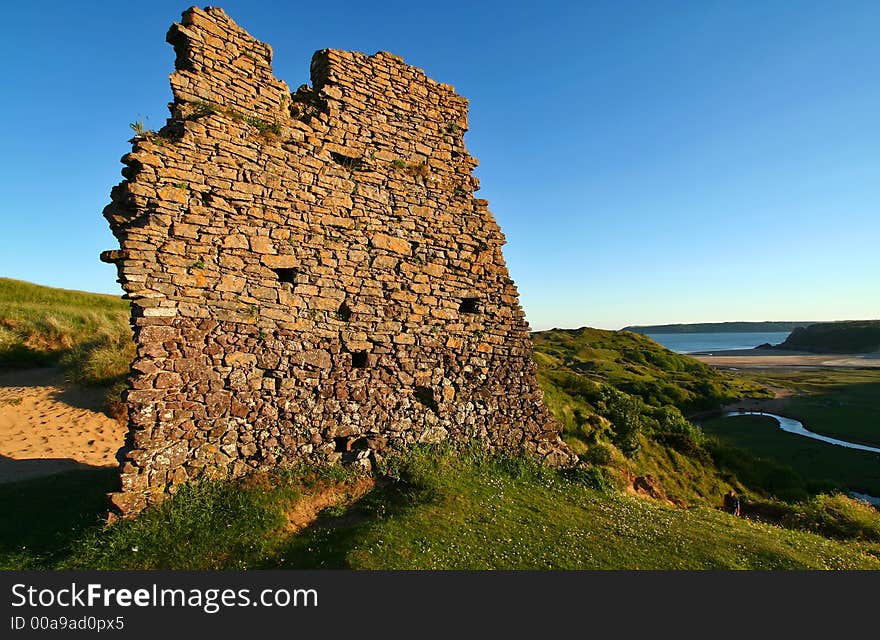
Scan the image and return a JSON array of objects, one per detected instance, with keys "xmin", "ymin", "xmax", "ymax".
[{"xmin": 312, "ymin": 452, "xmax": 880, "ymax": 569}]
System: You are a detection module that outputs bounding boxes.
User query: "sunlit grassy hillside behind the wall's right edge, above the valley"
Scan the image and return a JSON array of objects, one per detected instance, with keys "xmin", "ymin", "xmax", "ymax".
[{"xmin": 533, "ymin": 328, "xmax": 771, "ymax": 505}]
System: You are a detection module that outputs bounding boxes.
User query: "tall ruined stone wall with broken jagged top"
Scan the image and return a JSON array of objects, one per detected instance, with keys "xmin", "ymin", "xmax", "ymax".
[{"xmin": 102, "ymin": 8, "xmax": 574, "ymax": 513}]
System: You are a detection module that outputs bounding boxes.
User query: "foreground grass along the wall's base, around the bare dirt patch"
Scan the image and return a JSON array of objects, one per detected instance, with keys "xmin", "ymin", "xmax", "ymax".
[{"xmin": 6, "ymin": 447, "xmax": 880, "ymax": 569}]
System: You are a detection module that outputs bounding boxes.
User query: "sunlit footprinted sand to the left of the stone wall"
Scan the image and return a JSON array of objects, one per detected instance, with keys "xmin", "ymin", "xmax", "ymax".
[{"xmin": 0, "ymin": 368, "xmax": 126, "ymax": 483}]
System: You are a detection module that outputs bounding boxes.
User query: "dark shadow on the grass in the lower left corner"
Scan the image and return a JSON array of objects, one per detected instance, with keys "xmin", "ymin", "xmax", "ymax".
[{"xmin": 0, "ymin": 467, "xmax": 119, "ymax": 569}]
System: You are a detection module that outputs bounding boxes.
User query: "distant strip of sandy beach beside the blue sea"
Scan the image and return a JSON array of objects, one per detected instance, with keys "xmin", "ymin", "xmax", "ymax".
[{"xmin": 688, "ymin": 349, "xmax": 880, "ymax": 369}]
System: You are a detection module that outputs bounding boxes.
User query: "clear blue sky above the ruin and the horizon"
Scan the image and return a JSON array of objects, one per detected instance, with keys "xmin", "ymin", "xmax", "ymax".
[{"xmin": 0, "ymin": 0, "xmax": 880, "ymax": 329}]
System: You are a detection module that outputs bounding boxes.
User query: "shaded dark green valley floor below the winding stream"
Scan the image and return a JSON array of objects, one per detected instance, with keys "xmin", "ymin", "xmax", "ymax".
[{"xmin": 702, "ymin": 416, "xmax": 880, "ymax": 500}]
